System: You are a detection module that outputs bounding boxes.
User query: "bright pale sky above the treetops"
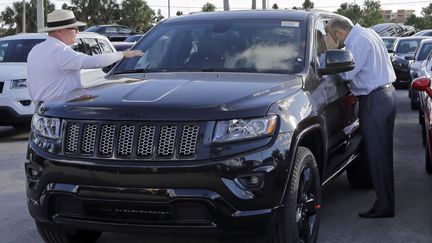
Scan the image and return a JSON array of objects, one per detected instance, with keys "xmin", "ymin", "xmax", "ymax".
[{"xmin": 0, "ymin": 0, "xmax": 431, "ymax": 17}]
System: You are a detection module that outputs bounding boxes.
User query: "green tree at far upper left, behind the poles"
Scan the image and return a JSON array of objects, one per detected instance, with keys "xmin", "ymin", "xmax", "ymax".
[{"xmin": 0, "ymin": 0, "xmax": 55, "ymax": 35}]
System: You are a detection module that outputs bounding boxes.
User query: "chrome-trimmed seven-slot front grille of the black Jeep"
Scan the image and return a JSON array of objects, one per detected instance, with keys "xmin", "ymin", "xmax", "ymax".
[{"xmin": 63, "ymin": 121, "xmax": 199, "ymax": 160}]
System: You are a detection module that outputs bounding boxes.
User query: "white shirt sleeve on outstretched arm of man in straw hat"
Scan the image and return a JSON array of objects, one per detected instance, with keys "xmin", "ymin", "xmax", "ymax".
[{"xmin": 57, "ymin": 47, "xmax": 123, "ymax": 71}]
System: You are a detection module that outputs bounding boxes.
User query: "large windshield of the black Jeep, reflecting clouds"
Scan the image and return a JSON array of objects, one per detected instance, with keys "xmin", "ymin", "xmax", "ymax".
[{"xmin": 114, "ymin": 20, "xmax": 306, "ymax": 73}]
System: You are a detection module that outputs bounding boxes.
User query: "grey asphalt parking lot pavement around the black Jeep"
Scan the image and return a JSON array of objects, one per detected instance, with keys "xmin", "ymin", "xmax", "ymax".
[{"xmin": 0, "ymin": 90, "xmax": 432, "ymax": 243}]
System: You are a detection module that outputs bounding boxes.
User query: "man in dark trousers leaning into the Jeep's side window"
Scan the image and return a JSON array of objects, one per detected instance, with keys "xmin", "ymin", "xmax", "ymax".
[{"xmin": 326, "ymin": 17, "xmax": 397, "ymax": 218}]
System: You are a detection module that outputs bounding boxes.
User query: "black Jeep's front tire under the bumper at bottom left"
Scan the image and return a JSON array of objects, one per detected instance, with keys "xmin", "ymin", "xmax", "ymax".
[{"xmin": 36, "ymin": 221, "xmax": 102, "ymax": 243}]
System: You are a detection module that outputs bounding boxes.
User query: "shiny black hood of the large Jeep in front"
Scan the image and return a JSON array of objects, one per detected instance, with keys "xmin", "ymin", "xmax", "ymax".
[{"xmin": 44, "ymin": 73, "xmax": 302, "ymax": 121}]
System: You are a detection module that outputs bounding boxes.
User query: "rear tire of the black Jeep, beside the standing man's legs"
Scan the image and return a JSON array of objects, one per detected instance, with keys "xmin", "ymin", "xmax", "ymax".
[{"xmin": 347, "ymin": 152, "xmax": 373, "ymax": 189}]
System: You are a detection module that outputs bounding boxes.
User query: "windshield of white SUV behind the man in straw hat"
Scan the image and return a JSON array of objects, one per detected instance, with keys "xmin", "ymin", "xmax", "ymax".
[{"xmin": 0, "ymin": 39, "xmax": 45, "ymax": 62}]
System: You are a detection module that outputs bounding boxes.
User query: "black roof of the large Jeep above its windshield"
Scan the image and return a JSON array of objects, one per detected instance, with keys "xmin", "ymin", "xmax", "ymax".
[{"xmin": 163, "ymin": 10, "xmax": 316, "ymax": 23}]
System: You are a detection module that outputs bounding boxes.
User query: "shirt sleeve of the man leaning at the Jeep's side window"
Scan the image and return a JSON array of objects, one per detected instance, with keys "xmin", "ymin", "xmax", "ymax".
[{"xmin": 341, "ymin": 38, "xmax": 371, "ymax": 80}]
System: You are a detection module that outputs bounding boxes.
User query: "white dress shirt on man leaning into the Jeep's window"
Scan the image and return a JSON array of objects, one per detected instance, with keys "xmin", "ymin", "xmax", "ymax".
[{"xmin": 342, "ymin": 24, "xmax": 396, "ymax": 96}]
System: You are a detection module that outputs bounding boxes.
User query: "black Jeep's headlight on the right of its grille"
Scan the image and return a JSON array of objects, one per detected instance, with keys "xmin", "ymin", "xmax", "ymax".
[{"xmin": 213, "ymin": 115, "xmax": 277, "ymax": 142}]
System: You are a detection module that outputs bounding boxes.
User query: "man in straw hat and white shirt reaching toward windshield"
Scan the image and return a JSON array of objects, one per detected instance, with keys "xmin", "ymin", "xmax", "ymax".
[{"xmin": 27, "ymin": 9, "xmax": 143, "ymax": 104}]
